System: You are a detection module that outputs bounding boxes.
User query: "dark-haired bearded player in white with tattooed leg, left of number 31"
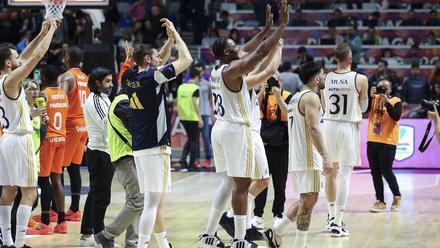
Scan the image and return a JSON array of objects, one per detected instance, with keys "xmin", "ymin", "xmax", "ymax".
[{"xmin": 264, "ymin": 61, "xmax": 331, "ymax": 248}]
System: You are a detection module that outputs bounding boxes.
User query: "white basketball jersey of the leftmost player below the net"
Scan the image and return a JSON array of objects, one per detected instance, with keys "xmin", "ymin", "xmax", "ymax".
[{"xmin": 0, "ymin": 75, "xmax": 33, "ymax": 135}]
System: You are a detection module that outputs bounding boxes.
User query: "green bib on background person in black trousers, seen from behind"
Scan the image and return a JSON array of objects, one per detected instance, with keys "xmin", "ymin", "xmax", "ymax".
[{"xmin": 177, "ymin": 83, "xmax": 199, "ymax": 121}]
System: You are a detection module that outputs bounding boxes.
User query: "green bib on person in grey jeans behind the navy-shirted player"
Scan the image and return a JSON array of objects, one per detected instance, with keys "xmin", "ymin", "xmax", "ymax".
[{"xmin": 107, "ymin": 94, "xmax": 133, "ymax": 162}]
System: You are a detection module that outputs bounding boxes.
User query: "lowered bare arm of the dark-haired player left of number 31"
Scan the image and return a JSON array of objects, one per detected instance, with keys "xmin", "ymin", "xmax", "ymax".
[{"xmin": 300, "ymin": 93, "xmax": 331, "ymax": 174}]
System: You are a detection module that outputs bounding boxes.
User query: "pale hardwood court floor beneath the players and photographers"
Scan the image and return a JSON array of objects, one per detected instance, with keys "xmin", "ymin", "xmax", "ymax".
[{"xmin": 27, "ymin": 171, "xmax": 440, "ymax": 248}]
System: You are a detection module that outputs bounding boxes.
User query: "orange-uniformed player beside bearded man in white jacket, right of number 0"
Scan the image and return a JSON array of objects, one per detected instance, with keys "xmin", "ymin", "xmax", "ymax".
[{"xmin": 58, "ymin": 47, "xmax": 90, "ymax": 222}]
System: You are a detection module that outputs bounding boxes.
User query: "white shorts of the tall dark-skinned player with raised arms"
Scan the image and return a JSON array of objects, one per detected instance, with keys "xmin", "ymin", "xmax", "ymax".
[{"xmin": 211, "ymin": 120, "xmax": 256, "ymax": 178}]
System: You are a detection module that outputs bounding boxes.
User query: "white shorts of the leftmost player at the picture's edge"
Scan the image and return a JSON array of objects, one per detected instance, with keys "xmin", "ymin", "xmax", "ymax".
[{"xmin": 0, "ymin": 134, "xmax": 38, "ymax": 187}]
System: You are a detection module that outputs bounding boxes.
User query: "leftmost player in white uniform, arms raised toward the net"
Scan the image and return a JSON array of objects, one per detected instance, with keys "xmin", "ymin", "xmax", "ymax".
[{"xmin": 0, "ymin": 20, "xmax": 60, "ymax": 248}]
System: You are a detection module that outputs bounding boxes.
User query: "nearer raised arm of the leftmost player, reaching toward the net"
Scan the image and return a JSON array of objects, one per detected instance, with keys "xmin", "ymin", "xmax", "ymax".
[{"xmin": 4, "ymin": 20, "xmax": 59, "ymax": 99}]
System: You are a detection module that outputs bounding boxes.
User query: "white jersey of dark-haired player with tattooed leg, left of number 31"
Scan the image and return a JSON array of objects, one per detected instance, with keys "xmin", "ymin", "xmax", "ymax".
[{"xmin": 287, "ymin": 90, "xmax": 323, "ymax": 171}]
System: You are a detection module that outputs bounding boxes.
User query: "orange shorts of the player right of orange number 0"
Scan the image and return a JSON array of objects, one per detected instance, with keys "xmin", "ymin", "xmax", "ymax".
[{"xmin": 63, "ymin": 126, "xmax": 88, "ymax": 167}]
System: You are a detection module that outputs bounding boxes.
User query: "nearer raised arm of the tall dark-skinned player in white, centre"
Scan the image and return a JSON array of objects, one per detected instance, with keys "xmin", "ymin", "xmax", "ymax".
[{"xmin": 223, "ymin": 0, "xmax": 289, "ymax": 91}]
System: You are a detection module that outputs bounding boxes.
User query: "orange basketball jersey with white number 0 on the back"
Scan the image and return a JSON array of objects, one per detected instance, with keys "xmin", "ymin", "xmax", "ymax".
[{"xmin": 44, "ymin": 87, "xmax": 69, "ymax": 139}]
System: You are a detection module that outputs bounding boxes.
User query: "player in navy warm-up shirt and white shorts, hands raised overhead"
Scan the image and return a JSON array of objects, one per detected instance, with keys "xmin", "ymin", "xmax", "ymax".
[{"xmin": 127, "ymin": 18, "xmax": 192, "ymax": 248}]
